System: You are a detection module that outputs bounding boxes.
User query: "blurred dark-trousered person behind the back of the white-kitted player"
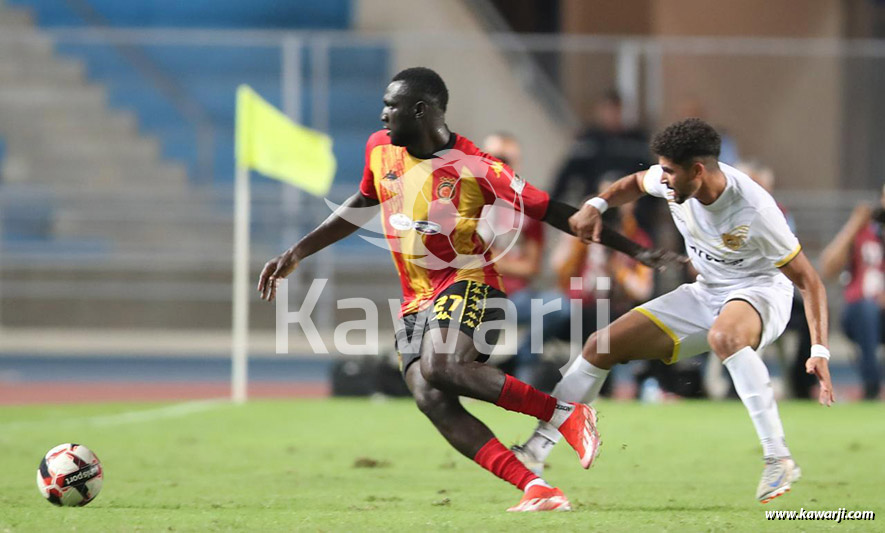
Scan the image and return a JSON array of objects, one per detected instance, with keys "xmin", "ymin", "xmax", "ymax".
[{"xmin": 737, "ymin": 160, "xmax": 815, "ymax": 399}]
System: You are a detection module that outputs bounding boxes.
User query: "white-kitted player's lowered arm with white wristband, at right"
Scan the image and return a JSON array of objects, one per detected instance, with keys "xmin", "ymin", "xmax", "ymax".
[{"xmin": 780, "ymin": 252, "xmax": 836, "ymax": 406}]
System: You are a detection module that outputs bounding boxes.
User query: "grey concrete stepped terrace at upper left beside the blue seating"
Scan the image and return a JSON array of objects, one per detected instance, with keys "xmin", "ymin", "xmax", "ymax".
[{"xmin": 0, "ymin": 5, "xmax": 187, "ymax": 214}]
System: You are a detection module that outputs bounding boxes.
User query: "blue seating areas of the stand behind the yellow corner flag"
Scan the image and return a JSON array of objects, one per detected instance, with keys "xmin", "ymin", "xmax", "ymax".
[{"xmin": 10, "ymin": 0, "xmax": 390, "ymax": 186}]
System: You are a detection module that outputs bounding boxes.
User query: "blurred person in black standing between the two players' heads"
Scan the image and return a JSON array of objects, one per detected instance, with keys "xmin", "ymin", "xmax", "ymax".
[{"xmin": 550, "ymin": 90, "xmax": 660, "ymax": 236}]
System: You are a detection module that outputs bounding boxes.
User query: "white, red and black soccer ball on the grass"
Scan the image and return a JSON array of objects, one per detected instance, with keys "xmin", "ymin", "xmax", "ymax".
[{"xmin": 37, "ymin": 444, "xmax": 104, "ymax": 507}]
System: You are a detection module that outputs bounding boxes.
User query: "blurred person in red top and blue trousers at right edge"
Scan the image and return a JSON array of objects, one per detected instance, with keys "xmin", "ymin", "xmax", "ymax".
[{"xmin": 821, "ymin": 186, "xmax": 885, "ymax": 400}]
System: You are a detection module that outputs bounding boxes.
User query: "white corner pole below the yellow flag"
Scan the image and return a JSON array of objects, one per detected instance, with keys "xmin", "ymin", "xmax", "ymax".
[{"xmin": 231, "ymin": 163, "xmax": 251, "ymax": 403}]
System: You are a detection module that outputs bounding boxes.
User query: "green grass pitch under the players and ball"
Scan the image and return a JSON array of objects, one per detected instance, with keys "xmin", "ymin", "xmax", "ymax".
[{"xmin": 0, "ymin": 400, "xmax": 885, "ymax": 532}]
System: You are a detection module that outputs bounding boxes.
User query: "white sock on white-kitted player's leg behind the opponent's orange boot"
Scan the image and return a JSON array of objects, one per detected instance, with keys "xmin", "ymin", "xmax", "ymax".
[{"xmin": 524, "ymin": 356, "xmax": 609, "ymax": 461}]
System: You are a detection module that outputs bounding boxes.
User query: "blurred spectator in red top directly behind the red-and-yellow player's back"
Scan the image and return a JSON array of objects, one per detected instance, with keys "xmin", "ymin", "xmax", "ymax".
[{"xmin": 483, "ymin": 132, "xmax": 570, "ymax": 384}]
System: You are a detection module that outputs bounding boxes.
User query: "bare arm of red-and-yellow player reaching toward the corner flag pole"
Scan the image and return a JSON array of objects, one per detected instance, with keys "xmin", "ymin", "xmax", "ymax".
[{"xmin": 258, "ymin": 193, "xmax": 378, "ymax": 302}]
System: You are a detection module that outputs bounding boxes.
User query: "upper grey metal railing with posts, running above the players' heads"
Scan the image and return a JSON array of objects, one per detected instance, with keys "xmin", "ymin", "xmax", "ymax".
[{"xmin": 31, "ymin": 28, "xmax": 885, "ymax": 139}]
